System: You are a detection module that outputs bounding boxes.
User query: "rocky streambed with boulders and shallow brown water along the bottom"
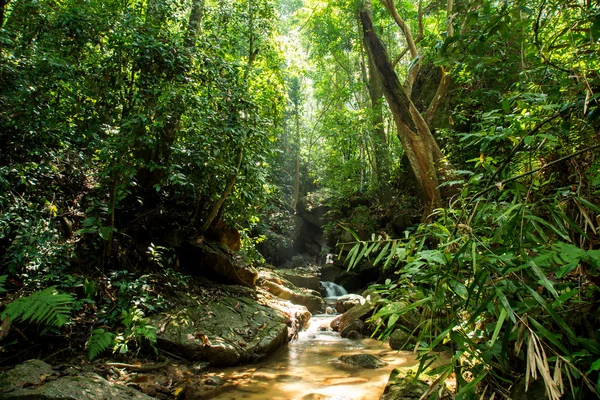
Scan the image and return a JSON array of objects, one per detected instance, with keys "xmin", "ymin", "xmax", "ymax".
[{"xmin": 0, "ymin": 269, "xmax": 440, "ymax": 400}]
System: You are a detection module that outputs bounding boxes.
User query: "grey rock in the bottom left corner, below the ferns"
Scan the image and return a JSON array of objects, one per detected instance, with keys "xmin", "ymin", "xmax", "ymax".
[{"xmin": 0, "ymin": 360, "xmax": 153, "ymax": 400}]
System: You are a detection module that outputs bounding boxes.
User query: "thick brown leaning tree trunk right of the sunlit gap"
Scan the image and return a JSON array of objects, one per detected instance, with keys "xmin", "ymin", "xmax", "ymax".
[{"xmin": 359, "ymin": 1, "xmax": 443, "ymax": 216}]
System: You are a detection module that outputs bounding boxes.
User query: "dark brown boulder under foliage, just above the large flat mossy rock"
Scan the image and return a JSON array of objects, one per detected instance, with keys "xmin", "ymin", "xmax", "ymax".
[{"xmin": 180, "ymin": 241, "xmax": 258, "ymax": 287}]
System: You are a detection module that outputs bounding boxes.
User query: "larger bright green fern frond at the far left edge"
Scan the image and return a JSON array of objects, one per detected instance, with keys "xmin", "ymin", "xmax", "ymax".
[{"xmin": 0, "ymin": 286, "xmax": 75, "ymax": 327}]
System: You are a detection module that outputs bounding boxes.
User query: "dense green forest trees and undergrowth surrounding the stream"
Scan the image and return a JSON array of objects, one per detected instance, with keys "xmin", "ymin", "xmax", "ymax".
[{"xmin": 0, "ymin": 0, "xmax": 600, "ymax": 399}]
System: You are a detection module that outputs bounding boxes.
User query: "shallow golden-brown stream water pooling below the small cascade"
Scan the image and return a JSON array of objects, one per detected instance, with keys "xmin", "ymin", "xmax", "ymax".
[{"xmin": 211, "ymin": 308, "xmax": 417, "ymax": 400}]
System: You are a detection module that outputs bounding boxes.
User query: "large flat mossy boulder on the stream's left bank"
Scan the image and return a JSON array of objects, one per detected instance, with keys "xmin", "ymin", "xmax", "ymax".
[{"xmin": 150, "ymin": 294, "xmax": 299, "ymax": 366}]
